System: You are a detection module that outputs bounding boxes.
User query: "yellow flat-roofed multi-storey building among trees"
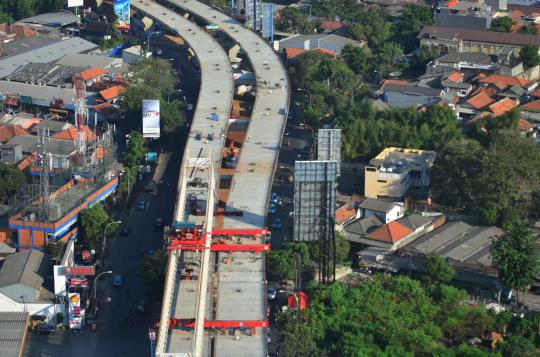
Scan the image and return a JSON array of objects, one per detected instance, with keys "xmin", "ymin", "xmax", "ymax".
[{"xmin": 364, "ymin": 147, "xmax": 435, "ymax": 200}]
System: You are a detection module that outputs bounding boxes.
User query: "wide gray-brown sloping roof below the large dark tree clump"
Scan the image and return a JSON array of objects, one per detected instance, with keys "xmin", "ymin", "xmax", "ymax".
[{"xmin": 406, "ymin": 221, "xmax": 504, "ymax": 267}]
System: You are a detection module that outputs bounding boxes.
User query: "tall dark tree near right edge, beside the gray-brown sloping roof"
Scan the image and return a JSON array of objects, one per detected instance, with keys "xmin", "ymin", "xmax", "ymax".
[{"xmin": 491, "ymin": 221, "xmax": 540, "ymax": 300}]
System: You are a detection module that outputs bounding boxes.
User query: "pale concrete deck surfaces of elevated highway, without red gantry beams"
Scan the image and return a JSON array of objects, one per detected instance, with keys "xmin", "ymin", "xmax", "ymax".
[{"xmin": 132, "ymin": 0, "xmax": 289, "ymax": 356}]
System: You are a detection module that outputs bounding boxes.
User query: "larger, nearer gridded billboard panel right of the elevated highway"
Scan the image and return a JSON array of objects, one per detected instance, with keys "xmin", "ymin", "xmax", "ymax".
[{"xmin": 293, "ymin": 161, "xmax": 337, "ymax": 241}]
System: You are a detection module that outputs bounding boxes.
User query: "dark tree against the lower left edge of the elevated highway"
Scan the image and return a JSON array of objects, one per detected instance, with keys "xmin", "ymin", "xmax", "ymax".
[{"xmin": 139, "ymin": 250, "xmax": 168, "ymax": 300}]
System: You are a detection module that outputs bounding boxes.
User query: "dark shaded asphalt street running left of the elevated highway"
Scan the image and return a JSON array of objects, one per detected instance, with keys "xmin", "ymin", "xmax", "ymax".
[{"xmin": 24, "ymin": 39, "xmax": 199, "ymax": 357}]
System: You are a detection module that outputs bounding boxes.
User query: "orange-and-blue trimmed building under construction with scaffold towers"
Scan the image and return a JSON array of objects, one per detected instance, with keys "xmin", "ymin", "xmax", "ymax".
[{"xmin": 9, "ymin": 127, "xmax": 118, "ymax": 223}]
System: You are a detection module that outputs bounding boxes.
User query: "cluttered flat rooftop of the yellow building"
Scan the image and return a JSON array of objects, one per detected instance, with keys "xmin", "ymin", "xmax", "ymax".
[{"xmin": 369, "ymin": 147, "xmax": 435, "ymax": 173}]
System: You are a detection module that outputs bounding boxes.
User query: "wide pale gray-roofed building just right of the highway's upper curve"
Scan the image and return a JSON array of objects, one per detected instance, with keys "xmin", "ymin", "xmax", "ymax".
[{"xmin": 279, "ymin": 34, "xmax": 366, "ymax": 54}]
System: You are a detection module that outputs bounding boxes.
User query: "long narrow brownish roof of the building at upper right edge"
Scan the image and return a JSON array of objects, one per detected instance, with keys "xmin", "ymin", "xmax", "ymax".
[{"xmin": 417, "ymin": 26, "xmax": 540, "ymax": 46}]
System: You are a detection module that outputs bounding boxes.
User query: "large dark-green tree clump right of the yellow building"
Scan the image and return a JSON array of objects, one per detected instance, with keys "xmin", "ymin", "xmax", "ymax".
[{"xmin": 431, "ymin": 132, "xmax": 540, "ymax": 225}]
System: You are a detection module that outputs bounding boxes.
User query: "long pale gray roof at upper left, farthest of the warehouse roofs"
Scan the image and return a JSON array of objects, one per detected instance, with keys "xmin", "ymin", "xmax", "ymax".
[{"xmin": 0, "ymin": 36, "xmax": 98, "ymax": 78}]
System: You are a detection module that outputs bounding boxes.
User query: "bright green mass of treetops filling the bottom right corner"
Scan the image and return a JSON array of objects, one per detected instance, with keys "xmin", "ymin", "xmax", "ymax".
[{"xmin": 278, "ymin": 256, "xmax": 540, "ymax": 357}]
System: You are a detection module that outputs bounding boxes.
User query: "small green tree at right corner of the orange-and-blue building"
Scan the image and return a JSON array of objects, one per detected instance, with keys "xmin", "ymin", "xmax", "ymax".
[{"xmin": 79, "ymin": 204, "xmax": 115, "ymax": 249}]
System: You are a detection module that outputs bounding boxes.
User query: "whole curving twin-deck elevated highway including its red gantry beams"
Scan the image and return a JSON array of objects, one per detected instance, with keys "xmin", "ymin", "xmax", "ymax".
[{"xmin": 132, "ymin": 0, "xmax": 290, "ymax": 357}]
